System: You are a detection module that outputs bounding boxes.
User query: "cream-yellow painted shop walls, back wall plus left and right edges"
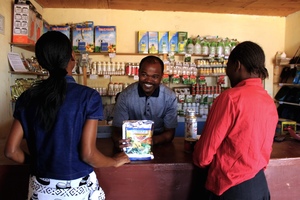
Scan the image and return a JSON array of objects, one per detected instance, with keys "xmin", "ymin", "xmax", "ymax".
[{"xmin": 0, "ymin": 0, "xmax": 300, "ymax": 139}]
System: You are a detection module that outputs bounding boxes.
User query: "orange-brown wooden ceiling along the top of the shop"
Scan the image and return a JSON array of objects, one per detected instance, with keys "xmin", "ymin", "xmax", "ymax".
[{"xmin": 35, "ymin": 0, "xmax": 300, "ymax": 16}]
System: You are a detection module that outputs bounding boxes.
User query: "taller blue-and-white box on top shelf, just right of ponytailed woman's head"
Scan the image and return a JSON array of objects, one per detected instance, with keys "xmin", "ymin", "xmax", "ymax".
[{"xmin": 72, "ymin": 21, "xmax": 95, "ymax": 53}]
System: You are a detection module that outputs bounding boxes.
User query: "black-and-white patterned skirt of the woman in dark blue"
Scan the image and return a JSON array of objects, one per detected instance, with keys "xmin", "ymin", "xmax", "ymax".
[{"xmin": 28, "ymin": 172, "xmax": 105, "ymax": 200}]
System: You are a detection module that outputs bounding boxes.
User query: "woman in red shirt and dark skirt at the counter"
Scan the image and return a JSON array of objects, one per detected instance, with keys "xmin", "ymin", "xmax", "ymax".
[{"xmin": 193, "ymin": 41, "xmax": 278, "ymax": 200}]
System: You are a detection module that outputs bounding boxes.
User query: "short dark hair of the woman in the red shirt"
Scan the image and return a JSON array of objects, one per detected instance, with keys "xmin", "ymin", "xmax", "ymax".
[{"xmin": 228, "ymin": 41, "xmax": 269, "ymax": 80}]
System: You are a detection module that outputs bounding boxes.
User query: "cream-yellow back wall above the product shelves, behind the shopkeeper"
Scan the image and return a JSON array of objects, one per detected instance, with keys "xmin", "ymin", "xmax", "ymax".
[{"xmin": 43, "ymin": 9, "xmax": 285, "ymax": 95}]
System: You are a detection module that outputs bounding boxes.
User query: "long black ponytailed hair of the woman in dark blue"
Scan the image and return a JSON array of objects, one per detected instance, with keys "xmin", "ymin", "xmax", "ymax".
[{"xmin": 26, "ymin": 31, "xmax": 72, "ymax": 132}]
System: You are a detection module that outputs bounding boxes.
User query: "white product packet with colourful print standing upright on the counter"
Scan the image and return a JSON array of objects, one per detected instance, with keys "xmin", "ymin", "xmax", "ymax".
[{"xmin": 122, "ymin": 120, "xmax": 154, "ymax": 160}]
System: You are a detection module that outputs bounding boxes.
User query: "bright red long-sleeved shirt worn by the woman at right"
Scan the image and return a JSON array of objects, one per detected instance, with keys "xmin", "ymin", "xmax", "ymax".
[{"xmin": 193, "ymin": 78, "xmax": 278, "ymax": 195}]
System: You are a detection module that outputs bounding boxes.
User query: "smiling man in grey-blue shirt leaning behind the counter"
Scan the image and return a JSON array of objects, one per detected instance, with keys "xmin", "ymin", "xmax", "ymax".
[{"xmin": 112, "ymin": 56, "xmax": 177, "ymax": 149}]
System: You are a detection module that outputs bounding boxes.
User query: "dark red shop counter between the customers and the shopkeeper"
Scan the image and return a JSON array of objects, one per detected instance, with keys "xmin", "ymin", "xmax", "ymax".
[{"xmin": 0, "ymin": 137, "xmax": 300, "ymax": 200}]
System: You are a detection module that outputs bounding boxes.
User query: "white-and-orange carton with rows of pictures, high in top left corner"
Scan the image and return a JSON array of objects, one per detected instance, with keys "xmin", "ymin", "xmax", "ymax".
[{"xmin": 12, "ymin": 4, "xmax": 36, "ymax": 44}]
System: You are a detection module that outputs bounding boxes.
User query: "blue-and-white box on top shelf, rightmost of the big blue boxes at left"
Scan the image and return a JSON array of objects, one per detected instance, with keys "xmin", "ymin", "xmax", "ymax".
[{"xmin": 95, "ymin": 26, "xmax": 117, "ymax": 53}]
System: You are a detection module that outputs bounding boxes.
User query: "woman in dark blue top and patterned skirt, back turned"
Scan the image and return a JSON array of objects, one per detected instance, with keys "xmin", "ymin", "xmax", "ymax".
[{"xmin": 4, "ymin": 31, "xmax": 129, "ymax": 200}]
